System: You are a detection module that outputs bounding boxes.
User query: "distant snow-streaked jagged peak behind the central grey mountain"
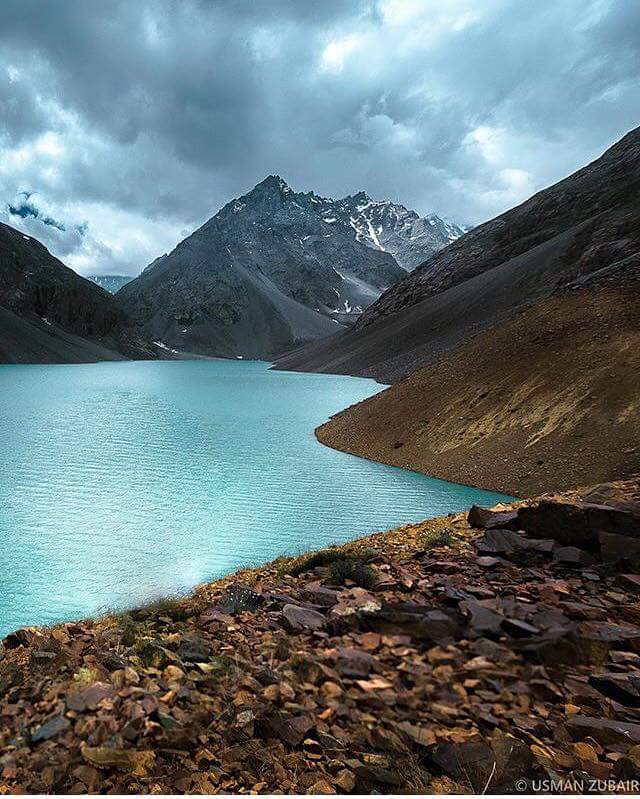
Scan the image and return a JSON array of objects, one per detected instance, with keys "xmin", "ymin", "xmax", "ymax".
[{"xmin": 317, "ymin": 191, "xmax": 468, "ymax": 271}]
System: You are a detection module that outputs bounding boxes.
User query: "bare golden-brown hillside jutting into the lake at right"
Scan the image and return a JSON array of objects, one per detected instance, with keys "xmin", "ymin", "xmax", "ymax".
[{"xmin": 316, "ymin": 276, "xmax": 640, "ymax": 496}]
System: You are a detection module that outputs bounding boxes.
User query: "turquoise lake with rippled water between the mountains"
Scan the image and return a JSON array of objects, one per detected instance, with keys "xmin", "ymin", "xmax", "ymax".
[{"xmin": 0, "ymin": 360, "xmax": 504, "ymax": 633}]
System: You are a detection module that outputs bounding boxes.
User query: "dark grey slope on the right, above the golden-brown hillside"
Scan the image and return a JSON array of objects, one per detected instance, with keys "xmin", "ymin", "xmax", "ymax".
[{"xmin": 279, "ymin": 129, "xmax": 640, "ymax": 382}]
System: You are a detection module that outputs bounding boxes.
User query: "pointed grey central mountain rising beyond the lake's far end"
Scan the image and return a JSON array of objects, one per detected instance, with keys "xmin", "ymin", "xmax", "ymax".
[{"xmin": 117, "ymin": 175, "xmax": 406, "ymax": 358}]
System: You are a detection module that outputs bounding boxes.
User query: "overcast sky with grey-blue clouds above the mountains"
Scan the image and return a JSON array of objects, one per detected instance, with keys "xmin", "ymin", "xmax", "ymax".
[{"xmin": 0, "ymin": 0, "xmax": 640, "ymax": 274}]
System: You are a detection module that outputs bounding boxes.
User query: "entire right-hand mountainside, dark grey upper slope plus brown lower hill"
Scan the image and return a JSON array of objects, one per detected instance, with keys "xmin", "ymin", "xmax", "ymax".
[{"xmin": 278, "ymin": 128, "xmax": 640, "ymax": 496}]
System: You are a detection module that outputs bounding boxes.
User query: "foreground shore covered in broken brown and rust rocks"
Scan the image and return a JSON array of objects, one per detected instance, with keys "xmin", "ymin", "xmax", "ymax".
[{"xmin": 0, "ymin": 480, "xmax": 640, "ymax": 793}]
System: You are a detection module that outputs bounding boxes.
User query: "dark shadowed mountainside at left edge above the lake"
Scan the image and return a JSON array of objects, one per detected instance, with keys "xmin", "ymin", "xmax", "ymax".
[{"xmin": 0, "ymin": 223, "xmax": 154, "ymax": 363}]
